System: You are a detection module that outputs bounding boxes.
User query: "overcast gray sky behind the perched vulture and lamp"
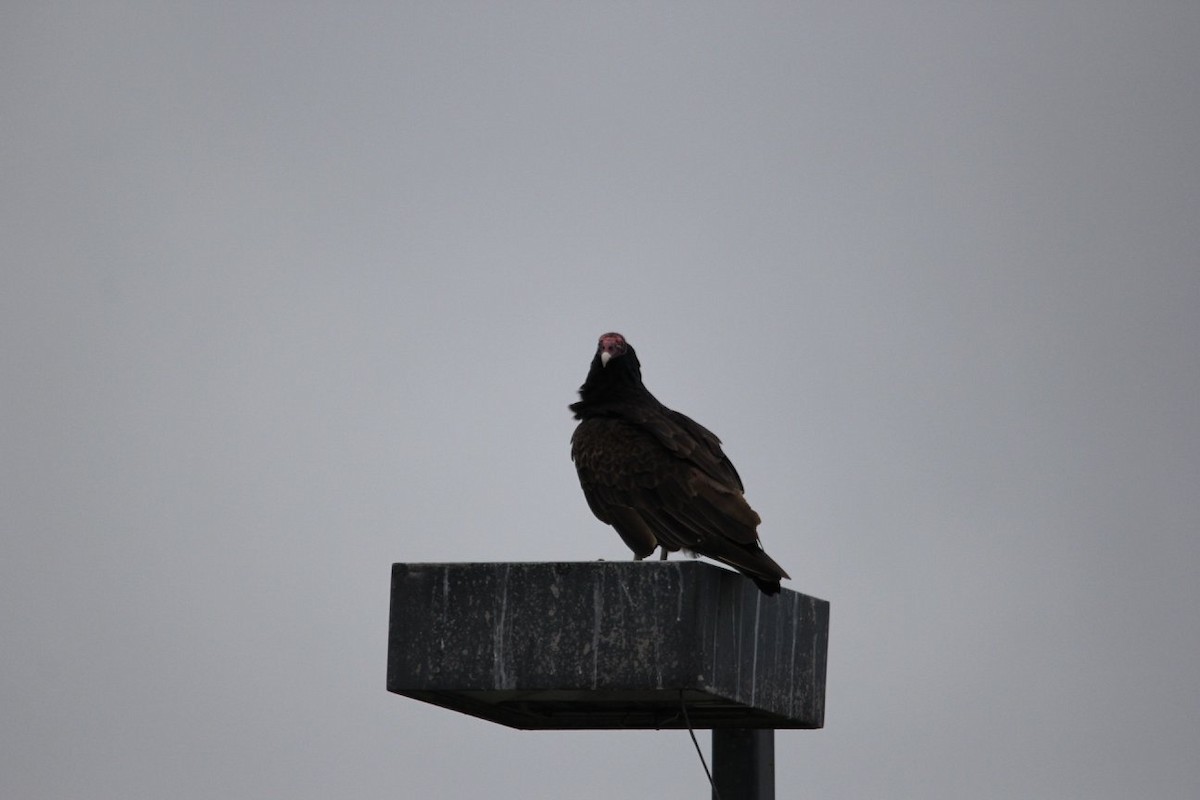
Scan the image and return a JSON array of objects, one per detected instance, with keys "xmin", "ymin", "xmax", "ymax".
[{"xmin": 0, "ymin": 2, "xmax": 1200, "ymax": 800}]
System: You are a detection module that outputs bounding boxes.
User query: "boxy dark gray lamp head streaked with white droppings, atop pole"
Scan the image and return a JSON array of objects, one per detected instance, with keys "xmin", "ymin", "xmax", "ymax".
[{"xmin": 388, "ymin": 561, "xmax": 829, "ymax": 729}]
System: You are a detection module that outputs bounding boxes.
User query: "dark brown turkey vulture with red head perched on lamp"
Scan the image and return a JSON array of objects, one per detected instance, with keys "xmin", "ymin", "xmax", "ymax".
[{"xmin": 568, "ymin": 332, "xmax": 791, "ymax": 595}]
